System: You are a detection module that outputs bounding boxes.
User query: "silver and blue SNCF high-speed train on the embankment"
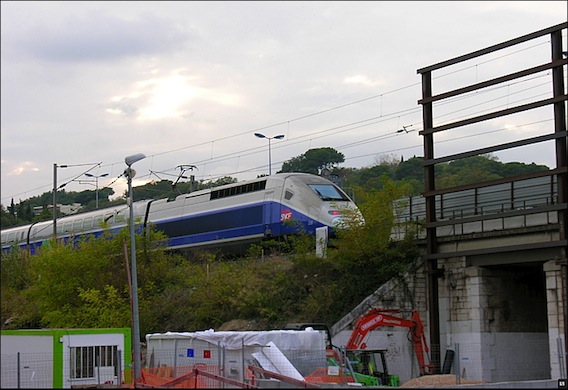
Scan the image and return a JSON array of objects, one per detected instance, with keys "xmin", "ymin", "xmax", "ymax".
[{"xmin": 2, "ymin": 173, "xmax": 358, "ymax": 253}]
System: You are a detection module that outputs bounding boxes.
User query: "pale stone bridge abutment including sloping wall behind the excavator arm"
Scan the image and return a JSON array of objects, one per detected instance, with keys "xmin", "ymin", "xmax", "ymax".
[{"xmin": 332, "ymin": 254, "xmax": 566, "ymax": 383}]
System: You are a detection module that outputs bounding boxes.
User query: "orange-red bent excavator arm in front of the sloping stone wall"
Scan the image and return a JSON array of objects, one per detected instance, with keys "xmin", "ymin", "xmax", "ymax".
[{"xmin": 346, "ymin": 309, "xmax": 433, "ymax": 375}]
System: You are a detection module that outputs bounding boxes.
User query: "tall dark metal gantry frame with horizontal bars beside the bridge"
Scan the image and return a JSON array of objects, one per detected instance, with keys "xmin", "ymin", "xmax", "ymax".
[{"xmin": 417, "ymin": 23, "xmax": 568, "ymax": 369}]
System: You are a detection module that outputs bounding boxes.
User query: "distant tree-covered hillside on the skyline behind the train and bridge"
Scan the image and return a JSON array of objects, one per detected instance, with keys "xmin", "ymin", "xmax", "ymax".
[{"xmin": 0, "ymin": 152, "xmax": 549, "ymax": 229}]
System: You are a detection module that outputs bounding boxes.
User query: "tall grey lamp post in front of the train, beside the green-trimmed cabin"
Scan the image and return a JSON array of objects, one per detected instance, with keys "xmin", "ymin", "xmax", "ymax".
[{"xmin": 124, "ymin": 153, "xmax": 146, "ymax": 383}]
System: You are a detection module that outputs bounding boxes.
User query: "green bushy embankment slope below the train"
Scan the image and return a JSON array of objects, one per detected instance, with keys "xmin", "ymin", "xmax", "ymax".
[{"xmin": 1, "ymin": 181, "xmax": 416, "ymax": 335}]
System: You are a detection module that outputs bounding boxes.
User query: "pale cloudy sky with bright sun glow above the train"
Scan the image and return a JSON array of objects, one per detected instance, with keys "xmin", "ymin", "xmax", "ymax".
[{"xmin": 0, "ymin": 1, "xmax": 568, "ymax": 206}]
